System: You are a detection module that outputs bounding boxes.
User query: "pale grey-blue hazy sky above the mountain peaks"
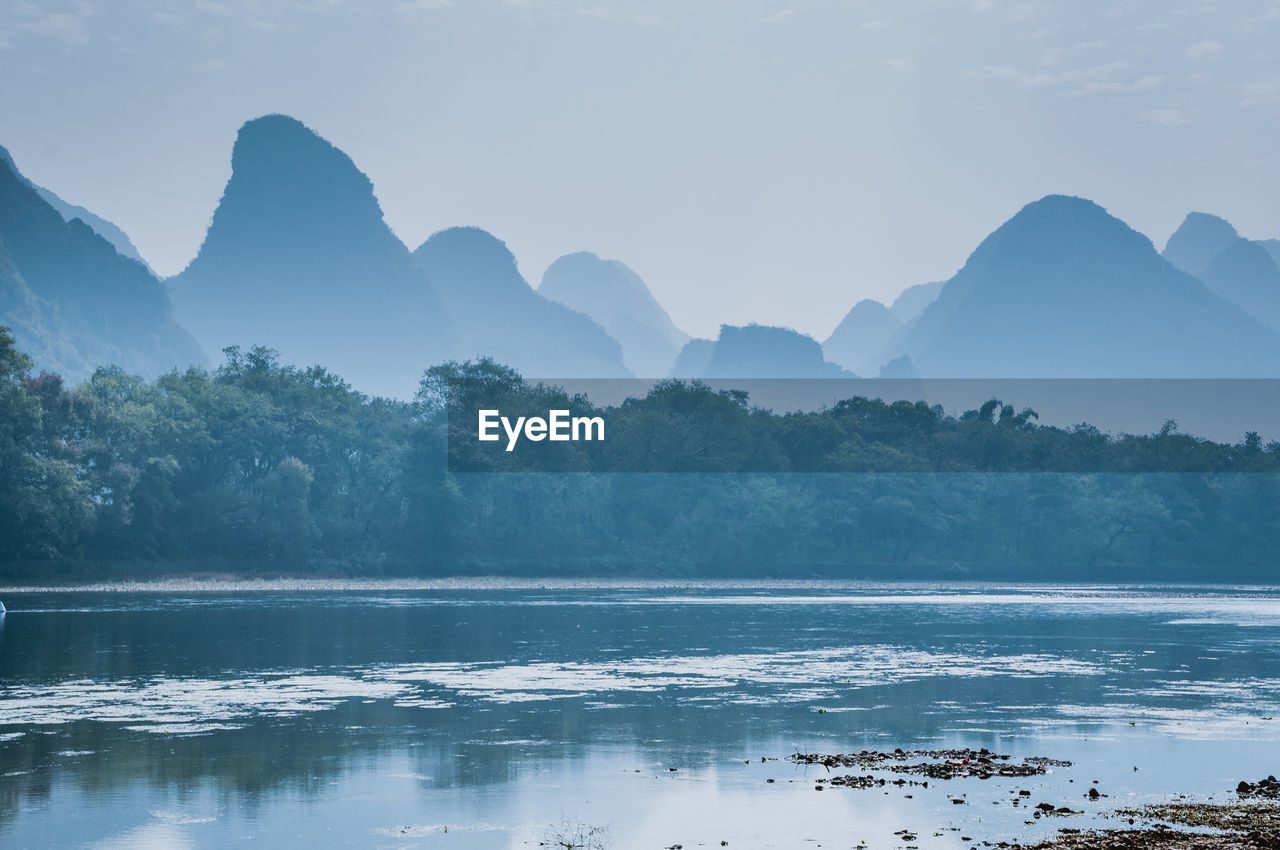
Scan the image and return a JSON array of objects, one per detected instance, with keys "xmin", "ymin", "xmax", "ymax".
[{"xmin": 0, "ymin": 0, "xmax": 1280, "ymax": 339}]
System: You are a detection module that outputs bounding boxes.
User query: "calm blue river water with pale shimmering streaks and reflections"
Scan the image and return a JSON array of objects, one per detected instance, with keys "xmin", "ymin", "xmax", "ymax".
[{"xmin": 0, "ymin": 584, "xmax": 1280, "ymax": 847}]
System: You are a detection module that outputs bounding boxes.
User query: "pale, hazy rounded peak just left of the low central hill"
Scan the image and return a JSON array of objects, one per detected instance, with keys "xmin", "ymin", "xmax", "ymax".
[{"xmin": 538, "ymin": 251, "xmax": 689, "ymax": 378}]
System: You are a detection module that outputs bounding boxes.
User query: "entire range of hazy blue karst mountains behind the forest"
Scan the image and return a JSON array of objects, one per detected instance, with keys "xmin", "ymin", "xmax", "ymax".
[{"xmin": 0, "ymin": 115, "xmax": 1280, "ymax": 389}]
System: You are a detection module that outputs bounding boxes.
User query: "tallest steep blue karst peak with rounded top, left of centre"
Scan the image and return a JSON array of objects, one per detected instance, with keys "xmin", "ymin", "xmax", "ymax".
[{"xmin": 172, "ymin": 115, "xmax": 454, "ymax": 398}]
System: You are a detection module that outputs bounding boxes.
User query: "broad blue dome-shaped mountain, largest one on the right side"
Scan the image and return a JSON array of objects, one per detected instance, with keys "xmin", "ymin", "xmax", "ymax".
[{"xmin": 882, "ymin": 196, "xmax": 1280, "ymax": 378}]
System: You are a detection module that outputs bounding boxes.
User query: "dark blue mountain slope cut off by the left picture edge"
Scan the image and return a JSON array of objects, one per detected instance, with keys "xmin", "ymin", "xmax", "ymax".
[{"xmin": 0, "ymin": 157, "xmax": 204, "ymax": 381}]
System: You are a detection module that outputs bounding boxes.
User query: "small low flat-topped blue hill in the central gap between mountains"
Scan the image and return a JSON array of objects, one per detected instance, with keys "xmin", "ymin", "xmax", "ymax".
[{"xmin": 672, "ymin": 324, "xmax": 851, "ymax": 378}]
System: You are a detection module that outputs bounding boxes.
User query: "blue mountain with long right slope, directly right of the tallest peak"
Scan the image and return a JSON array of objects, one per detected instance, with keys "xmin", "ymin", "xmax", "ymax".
[{"xmin": 413, "ymin": 228, "xmax": 630, "ymax": 378}]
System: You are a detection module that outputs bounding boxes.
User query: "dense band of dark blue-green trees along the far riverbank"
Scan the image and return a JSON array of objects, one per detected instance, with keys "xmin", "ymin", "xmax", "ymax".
[{"xmin": 0, "ymin": 330, "xmax": 1280, "ymax": 581}]
